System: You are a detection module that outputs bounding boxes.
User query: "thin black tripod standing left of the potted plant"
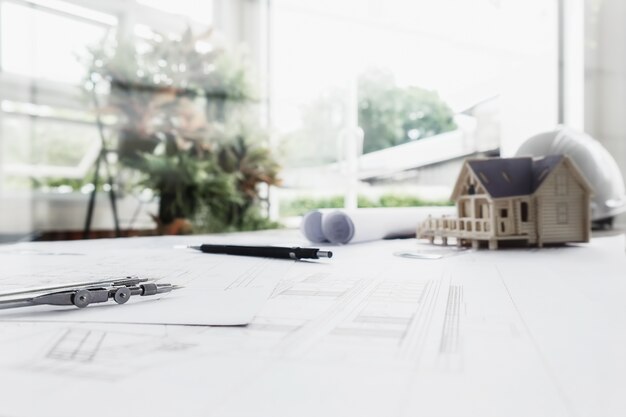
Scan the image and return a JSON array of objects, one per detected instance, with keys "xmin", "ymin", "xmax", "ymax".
[{"xmin": 83, "ymin": 80, "xmax": 122, "ymax": 239}]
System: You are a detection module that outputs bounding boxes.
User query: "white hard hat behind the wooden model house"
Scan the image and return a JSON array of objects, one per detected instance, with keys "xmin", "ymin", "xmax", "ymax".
[{"xmin": 516, "ymin": 127, "xmax": 626, "ymax": 224}]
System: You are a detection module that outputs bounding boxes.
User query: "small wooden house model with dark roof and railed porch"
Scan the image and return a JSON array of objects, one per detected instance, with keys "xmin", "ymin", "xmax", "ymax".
[{"xmin": 417, "ymin": 155, "xmax": 592, "ymax": 249}]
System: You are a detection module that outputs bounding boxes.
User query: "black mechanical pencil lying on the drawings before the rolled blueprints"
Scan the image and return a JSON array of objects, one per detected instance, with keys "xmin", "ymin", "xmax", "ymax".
[{"xmin": 189, "ymin": 244, "xmax": 333, "ymax": 259}]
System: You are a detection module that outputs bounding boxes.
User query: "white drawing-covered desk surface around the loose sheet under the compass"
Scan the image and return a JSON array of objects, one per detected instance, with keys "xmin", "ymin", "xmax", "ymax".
[{"xmin": 0, "ymin": 231, "xmax": 626, "ymax": 417}]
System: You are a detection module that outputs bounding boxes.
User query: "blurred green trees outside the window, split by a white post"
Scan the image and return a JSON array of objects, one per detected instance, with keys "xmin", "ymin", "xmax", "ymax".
[{"xmin": 281, "ymin": 69, "xmax": 457, "ymax": 166}]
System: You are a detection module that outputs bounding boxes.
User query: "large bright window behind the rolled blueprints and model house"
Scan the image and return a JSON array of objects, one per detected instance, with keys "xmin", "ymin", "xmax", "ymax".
[{"xmin": 270, "ymin": 0, "xmax": 558, "ymax": 219}]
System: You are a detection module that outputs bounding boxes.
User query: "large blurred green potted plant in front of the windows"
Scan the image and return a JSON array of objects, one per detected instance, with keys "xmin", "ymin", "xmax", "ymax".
[{"xmin": 87, "ymin": 29, "xmax": 279, "ymax": 232}]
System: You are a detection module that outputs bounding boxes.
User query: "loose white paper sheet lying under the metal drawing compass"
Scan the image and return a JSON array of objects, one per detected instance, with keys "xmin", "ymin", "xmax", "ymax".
[{"xmin": 0, "ymin": 234, "xmax": 290, "ymax": 325}]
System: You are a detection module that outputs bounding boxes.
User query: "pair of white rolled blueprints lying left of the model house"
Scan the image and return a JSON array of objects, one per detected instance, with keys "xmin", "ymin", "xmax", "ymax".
[{"xmin": 300, "ymin": 207, "xmax": 456, "ymax": 244}]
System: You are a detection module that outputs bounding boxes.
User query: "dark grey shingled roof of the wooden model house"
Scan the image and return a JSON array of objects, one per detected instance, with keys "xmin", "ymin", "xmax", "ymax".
[{"xmin": 452, "ymin": 155, "xmax": 588, "ymax": 199}]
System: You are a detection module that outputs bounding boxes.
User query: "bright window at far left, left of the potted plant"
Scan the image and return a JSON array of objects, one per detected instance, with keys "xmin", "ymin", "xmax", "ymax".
[{"xmin": 0, "ymin": 1, "xmax": 117, "ymax": 185}]
